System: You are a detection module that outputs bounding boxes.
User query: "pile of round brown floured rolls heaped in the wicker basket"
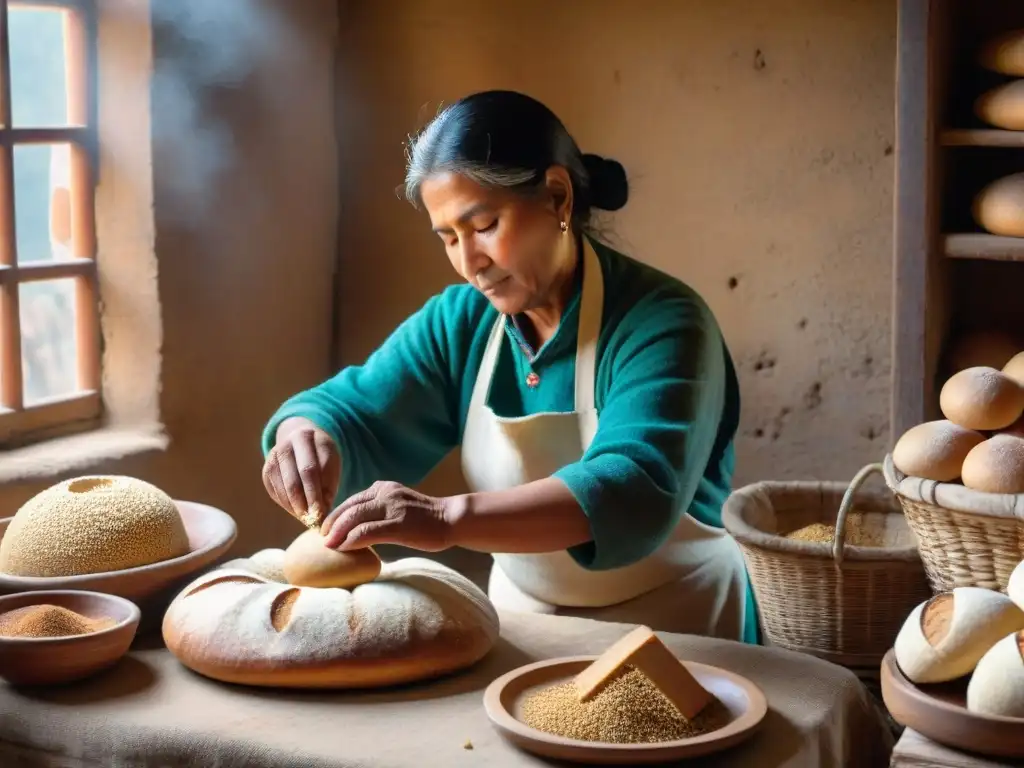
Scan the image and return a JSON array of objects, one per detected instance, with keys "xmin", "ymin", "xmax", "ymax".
[{"xmin": 893, "ymin": 351, "xmax": 1024, "ymax": 494}]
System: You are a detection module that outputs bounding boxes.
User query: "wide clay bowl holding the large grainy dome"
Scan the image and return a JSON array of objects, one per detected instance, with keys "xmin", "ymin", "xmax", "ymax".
[{"xmin": 0, "ymin": 501, "xmax": 238, "ymax": 620}]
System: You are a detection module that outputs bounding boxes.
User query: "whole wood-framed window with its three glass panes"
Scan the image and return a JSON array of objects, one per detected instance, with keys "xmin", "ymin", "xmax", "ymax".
[{"xmin": 0, "ymin": 0, "xmax": 101, "ymax": 449}]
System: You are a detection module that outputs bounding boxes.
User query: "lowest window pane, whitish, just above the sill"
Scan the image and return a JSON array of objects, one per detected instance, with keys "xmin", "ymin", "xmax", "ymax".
[{"xmin": 18, "ymin": 278, "xmax": 78, "ymax": 406}]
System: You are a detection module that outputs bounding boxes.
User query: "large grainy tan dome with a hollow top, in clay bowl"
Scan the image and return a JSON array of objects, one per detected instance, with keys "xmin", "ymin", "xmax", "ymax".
[{"xmin": 0, "ymin": 475, "xmax": 189, "ymax": 577}]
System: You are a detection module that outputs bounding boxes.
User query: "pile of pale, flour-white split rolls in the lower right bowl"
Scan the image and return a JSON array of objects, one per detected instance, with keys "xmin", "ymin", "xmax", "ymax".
[{"xmin": 893, "ymin": 562, "xmax": 1024, "ymax": 718}]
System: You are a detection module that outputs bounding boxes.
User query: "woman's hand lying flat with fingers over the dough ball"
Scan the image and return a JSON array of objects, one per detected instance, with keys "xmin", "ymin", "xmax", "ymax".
[{"xmin": 321, "ymin": 482, "xmax": 452, "ymax": 552}]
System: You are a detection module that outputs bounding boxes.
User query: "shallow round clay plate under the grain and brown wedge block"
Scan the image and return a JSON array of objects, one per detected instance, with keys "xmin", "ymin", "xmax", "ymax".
[{"xmin": 483, "ymin": 656, "xmax": 768, "ymax": 765}]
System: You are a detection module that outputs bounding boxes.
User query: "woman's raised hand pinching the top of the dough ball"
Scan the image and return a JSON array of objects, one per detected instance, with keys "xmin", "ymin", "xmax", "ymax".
[{"xmin": 263, "ymin": 419, "xmax": 341, "ymax": 526}]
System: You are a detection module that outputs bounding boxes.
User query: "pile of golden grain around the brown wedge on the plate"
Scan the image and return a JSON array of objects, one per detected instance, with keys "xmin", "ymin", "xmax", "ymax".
[{"xmin": 521, "ymin": 668, "xmax": 729, "ymax": 744}]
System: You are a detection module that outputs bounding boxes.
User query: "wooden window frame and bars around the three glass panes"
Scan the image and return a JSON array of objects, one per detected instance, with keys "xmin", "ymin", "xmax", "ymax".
[{"xmin": 0, "ymin": 0, "xmax": 102, "ymax": 451}]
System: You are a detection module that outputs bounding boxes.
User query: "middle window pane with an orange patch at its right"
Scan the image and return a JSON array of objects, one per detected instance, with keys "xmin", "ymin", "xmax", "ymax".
[{"xmin": 14, "ymin": 144, "xmax": 71, "ymax": 264}]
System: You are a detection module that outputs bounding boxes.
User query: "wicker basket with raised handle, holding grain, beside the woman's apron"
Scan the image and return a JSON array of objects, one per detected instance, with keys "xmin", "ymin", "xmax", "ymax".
[{"xmin": 722, "ymin": 464, "xmax": 931, "ymax": 669}]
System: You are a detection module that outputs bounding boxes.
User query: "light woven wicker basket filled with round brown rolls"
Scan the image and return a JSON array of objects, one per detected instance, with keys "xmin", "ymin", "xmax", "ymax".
[{"xmin": 885, "ymin": 454, "xmax": 1024, "ymax": 592}]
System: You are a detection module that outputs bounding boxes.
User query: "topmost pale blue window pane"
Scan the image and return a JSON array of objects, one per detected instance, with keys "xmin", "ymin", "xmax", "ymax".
[{"xmin": 9, "ymin": 7, "xmax": 68, "ymax": 128}]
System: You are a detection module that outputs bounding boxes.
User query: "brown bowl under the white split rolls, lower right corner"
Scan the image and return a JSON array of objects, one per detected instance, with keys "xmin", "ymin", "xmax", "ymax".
[{"xmin": 882, "ymin": 650, "xmax": 1024, "ymax": 758}]
